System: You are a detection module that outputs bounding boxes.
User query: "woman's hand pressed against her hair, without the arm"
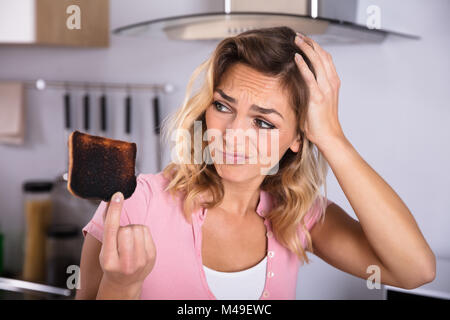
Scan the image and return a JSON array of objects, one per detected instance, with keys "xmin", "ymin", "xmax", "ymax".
[{"xmin": 295, "ymin": 33, "xmax": 345, "ymax": 147}]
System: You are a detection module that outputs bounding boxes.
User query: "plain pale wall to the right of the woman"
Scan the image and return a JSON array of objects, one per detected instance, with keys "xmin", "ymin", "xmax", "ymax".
[{"xmin": 297, "ymin": 0, "xmax": 450, "ymax": 299}]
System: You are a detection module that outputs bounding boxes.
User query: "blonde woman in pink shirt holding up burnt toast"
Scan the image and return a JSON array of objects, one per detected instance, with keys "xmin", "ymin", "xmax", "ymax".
[{"xmin": 77, "ymin": 27, "xmax": 435, "ymax": 299}]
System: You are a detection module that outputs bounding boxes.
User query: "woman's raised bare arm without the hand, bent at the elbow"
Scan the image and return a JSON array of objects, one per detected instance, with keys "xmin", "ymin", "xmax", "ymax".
[{"xmin": 313, "ymin": 138, "xmax": 436, "ymax": 289}]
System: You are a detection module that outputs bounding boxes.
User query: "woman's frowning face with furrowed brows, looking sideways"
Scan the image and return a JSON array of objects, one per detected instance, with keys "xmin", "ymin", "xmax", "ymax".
[{"xmin": 205, "ymin": 63, "xmax": 301, "ymax": 181}]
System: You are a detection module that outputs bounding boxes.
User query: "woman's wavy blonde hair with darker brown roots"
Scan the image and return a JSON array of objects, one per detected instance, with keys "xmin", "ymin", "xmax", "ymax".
[{"xmin": 161, "ymin": 27, "xmax": 328, "ymax": 263}]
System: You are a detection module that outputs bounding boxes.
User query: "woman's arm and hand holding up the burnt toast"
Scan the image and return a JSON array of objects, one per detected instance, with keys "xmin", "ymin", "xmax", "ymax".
[{"xmin": 76, "ymin": 192, "xmax": 156, "ymax": 299}]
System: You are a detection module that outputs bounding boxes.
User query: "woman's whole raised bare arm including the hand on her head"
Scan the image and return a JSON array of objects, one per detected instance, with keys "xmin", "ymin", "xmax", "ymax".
[{"xmin": 295, "ymin": 35, "xmax": 436, "ymax": 288}]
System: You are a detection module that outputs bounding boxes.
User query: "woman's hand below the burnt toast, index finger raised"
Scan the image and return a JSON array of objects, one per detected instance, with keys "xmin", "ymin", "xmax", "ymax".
[{"xmin": 97, "ymin": 192, "xmax": 156, "ymax": 299}]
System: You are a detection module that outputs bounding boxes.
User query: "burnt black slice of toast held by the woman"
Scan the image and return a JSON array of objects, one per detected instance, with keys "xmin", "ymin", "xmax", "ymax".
[{"xmin": 68, "ymin": 131, "xmax": 137, "ymax": 201}]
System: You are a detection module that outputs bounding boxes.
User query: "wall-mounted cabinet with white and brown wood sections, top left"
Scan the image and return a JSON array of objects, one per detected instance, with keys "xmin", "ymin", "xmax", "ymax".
[{"xmin": 0, "ymin": 0, "xmax": 109, "ymax": 47}]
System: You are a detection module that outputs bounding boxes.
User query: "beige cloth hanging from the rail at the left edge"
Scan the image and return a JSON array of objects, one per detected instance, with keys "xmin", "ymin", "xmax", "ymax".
[{"xmin": 0, "ymin": 82, "xmax": 25, "ymax": 145}]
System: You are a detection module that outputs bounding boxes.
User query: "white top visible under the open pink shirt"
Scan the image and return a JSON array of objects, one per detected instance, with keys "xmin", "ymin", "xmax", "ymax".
[{"xmin": 203, "ymin": 255, "xmax": 267, "ymax": 300}]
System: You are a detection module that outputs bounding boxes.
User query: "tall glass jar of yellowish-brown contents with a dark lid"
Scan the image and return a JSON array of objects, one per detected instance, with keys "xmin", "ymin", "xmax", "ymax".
[{"xmin": 22, "ymin": 180, "xmax": 53, "ymax": 283}]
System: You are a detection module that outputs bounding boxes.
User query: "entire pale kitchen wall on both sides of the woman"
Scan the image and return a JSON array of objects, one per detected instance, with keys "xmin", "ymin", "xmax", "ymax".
[{"xmin": 0, "ymin": 0, "xmax": 450, "ymax": 299}]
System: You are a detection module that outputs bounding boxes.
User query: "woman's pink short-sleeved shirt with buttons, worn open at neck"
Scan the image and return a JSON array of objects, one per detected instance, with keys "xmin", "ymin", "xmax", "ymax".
[{"xmin": 83, "ymin": 172, "xmax": 332, "ymax": 300}]
